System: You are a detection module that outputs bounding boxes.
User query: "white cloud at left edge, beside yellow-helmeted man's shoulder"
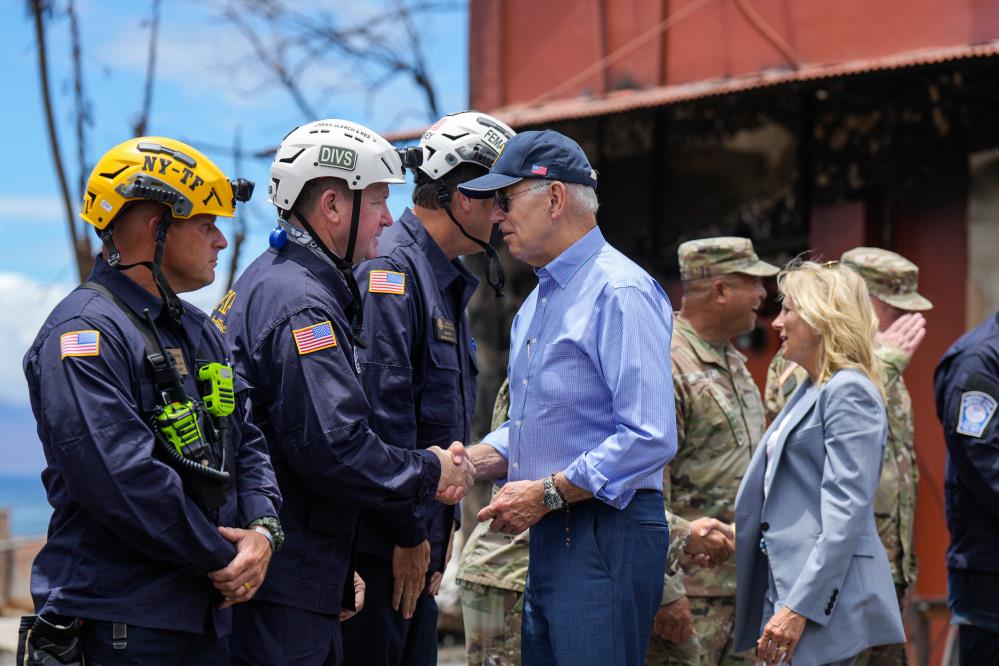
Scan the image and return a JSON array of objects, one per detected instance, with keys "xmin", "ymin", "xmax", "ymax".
[{"xmin": 0, "ymin": 272, "xmax": 72, "ymax": 405}]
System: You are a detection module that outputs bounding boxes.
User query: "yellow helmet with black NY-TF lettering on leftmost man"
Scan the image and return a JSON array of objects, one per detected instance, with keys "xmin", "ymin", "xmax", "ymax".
[{"xmin": 80, "ymin": 136, "xmax": 253, "ymax": 230}]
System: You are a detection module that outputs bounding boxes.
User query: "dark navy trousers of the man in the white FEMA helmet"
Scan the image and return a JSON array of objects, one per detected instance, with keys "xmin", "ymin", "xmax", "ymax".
[{"xmin": 342, "ymin": 553, "xmax": 437, "ymax": 666}]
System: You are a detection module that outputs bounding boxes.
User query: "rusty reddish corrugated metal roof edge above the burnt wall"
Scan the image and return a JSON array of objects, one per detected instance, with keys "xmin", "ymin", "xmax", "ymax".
[{"xmin": 384, "ymin": 40, "xmax": 999, "ymax": 141}]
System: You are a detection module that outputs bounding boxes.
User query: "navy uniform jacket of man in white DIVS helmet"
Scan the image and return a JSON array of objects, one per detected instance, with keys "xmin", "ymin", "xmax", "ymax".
[{"xmin": 212, "ymin": 238, "xmax": 440, "ymax": 614}]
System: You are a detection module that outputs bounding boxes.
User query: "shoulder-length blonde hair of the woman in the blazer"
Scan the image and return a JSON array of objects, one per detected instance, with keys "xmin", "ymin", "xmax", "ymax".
[{"xmin": 777, "ymin": 261, "xmax": 884, "ymax": 398}]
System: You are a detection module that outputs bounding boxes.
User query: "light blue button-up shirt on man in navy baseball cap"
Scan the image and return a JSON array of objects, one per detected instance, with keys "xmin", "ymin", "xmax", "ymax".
[{"xmin": 482, "ymin": 228, "xmax": 676, "ymax": 508}]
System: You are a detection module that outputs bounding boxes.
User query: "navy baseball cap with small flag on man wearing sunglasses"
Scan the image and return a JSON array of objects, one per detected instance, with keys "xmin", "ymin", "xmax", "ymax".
[{"xmin": 458, "ymin": 130, "xmax": 597, "ymax": 199}]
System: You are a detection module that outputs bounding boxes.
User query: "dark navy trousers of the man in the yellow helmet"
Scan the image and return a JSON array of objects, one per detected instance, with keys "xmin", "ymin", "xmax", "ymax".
[{"xmin": 82, "ymin": 620, "xmax": 229, "ymax": 666}]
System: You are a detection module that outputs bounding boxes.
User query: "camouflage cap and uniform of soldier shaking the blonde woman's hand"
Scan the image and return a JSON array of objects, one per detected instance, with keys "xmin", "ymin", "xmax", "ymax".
[{"xmin": 646, "ymin": 238, "xmax": 778, "ymax": 666}]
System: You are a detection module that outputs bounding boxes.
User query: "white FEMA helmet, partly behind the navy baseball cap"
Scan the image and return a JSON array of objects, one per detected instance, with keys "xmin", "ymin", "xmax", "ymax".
[{"xmin": 420, "ymin": 111, "xmax": 516, "ymax": 180}]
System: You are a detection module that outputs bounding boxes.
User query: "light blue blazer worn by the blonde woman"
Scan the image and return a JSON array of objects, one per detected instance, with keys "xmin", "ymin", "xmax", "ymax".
[{"xmin": 735, "ymin": 370, "xmax": 905, "ymax": 666}]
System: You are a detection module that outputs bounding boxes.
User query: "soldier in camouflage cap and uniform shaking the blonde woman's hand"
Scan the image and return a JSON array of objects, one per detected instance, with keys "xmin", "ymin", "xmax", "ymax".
[{"xmin": 646, "ymin": 237, "xmax": 779, "ymax": 666}]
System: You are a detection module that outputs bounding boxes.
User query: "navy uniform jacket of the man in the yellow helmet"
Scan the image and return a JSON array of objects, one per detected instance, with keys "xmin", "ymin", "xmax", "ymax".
[{"xmin": 24, "ymin": 258, "xmax": 281, "ymax": 636}]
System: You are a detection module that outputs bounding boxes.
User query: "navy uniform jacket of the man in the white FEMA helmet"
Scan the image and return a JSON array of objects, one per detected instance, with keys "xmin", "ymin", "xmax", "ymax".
[{"xmin": 355, "ymin": 209, "xmax": 479, "ymax": 571}]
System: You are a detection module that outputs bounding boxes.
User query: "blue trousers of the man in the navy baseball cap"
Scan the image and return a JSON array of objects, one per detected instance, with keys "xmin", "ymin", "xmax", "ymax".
[{"xmin": 521, "ymin": 491, "xmax": 669, "ymax": 666}]
